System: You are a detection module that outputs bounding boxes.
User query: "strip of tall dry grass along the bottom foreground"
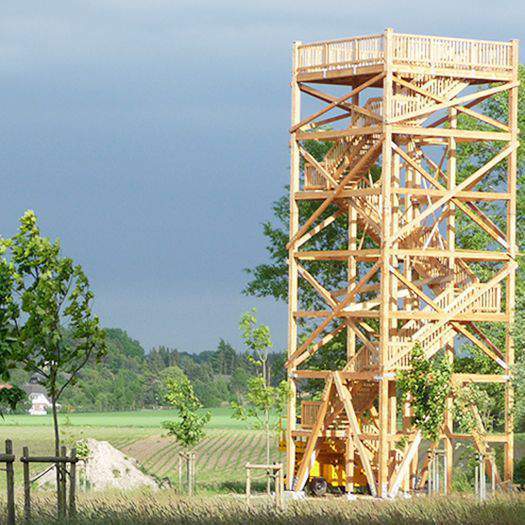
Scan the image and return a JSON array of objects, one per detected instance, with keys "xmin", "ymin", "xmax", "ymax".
[{"xmin": 6, "ymin": 491, "xmax": 525, "ymax": 525}]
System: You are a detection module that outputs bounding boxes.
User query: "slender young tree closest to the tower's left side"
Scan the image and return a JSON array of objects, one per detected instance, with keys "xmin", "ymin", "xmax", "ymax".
[{"xmin": 232, "ymin": 308, "xmax": 287, "ymax": 482}]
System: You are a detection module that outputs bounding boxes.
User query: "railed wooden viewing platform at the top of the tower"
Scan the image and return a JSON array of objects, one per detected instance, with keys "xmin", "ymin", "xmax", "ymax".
[{"xmin": 295, "ymin": 29, "xmax": 516, "ymax": 84}]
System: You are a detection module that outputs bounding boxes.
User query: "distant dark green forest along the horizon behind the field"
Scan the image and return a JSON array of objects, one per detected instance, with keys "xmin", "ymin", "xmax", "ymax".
[{"xmin": 13, "ymin": 328, "xmax": 284, "ymax": 412}]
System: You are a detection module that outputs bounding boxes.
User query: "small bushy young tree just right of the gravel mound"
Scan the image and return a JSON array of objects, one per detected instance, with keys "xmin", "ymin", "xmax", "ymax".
[{"xmin": 162, "ymin": 376, "xmax": 211, "ymax": 494}]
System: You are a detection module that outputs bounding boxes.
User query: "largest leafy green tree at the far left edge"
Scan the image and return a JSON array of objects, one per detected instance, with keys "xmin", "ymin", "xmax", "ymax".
[{"xmin": 0, "ymin": 211, "xmax": 106, "ymax": 456}]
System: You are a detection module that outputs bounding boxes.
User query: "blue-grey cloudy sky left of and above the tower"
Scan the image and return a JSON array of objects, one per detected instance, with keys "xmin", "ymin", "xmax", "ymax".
[{"xmin": 0, "ymin": 0, "xmax": 525, "ymax": 352}]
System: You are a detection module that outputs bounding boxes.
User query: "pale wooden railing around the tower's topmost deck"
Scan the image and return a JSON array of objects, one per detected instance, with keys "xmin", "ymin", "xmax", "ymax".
[{"xmin": 297, "ymin": 33, "xmax": 512, "ymax": 72}]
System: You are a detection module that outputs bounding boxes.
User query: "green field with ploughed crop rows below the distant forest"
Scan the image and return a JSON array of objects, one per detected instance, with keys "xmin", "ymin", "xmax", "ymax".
[{"xmin": 0, "ymin": 408, "xmax": 280, "ymax": 492}]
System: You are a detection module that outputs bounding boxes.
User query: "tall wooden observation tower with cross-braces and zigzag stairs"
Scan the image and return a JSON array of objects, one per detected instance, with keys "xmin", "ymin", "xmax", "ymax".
[{"xmin": 286, "ymin": 29, "xmax": 518, "ymax": 497}]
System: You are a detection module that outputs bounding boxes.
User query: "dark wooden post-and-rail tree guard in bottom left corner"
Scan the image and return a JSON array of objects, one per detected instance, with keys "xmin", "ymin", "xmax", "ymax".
[{"xmin": 0, "ymin": 439, "xmax": 78, "ymax": 525}]
